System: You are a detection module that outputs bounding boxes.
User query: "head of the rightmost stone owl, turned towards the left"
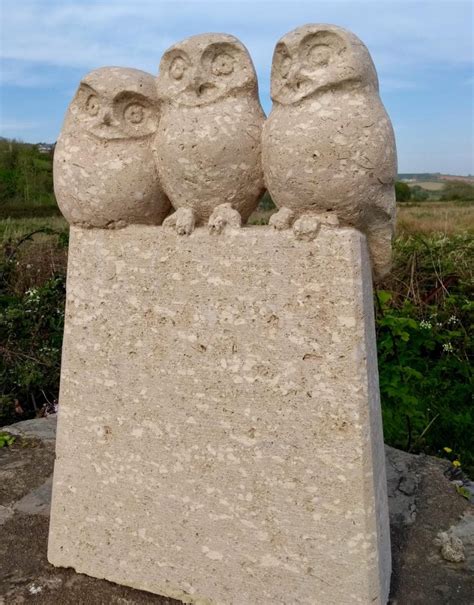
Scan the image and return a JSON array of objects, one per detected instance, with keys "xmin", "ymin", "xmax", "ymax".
[{"xmin": 271, "ymin": 23, "xmax": 378, "ymax": 105}]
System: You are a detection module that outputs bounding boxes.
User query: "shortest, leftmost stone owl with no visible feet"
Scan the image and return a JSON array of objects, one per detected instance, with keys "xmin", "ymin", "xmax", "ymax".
[{"xmin": 54, "ymin": 67, "xmax": 171, "ymax": 228}]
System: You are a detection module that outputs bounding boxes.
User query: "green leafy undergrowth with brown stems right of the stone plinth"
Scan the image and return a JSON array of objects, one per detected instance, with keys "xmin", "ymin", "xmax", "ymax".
[{"xmin": 376, "ymin": 236, "xmax": 474, "ymax": 475}]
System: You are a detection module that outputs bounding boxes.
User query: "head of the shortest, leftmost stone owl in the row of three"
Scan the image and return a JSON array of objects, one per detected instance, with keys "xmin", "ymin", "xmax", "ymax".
[{"xmin": 65, "ymin": 67, "xmax": 159, "ymax": 140}]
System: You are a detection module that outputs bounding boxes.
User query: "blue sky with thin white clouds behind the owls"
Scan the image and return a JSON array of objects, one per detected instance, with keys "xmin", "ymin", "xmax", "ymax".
[{"xmin": 0, "ymin": 0, "xmax": 474, "ymax": 174}]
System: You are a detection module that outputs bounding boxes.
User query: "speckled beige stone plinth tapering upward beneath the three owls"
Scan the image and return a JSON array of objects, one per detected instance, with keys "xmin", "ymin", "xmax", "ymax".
[{"xmin": 49, "ymin": 226, "xmax": 390, "ymax": 605}]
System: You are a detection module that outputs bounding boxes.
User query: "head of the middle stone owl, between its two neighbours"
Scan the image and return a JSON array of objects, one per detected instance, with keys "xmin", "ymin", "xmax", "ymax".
[{"xmin": 157, "ymin": 34, "xmax": 257, "ymax": 107}]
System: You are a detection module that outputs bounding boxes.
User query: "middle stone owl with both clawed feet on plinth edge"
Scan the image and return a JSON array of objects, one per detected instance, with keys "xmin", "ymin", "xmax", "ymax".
[{"xmin": 154, "ymin": 34, "xmax": 265, "ymax": 234}]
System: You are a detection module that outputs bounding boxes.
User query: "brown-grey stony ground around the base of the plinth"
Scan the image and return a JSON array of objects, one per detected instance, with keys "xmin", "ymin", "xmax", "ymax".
[{"xmin": 0, "ymin": 417, "xmax": 474, "ymax": 605}]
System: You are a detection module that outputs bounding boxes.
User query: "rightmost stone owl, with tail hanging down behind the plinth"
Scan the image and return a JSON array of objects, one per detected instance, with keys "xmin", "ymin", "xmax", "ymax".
[{"xmin": 262, "ymin": 24, "xmax": 397, "ymax": 278}]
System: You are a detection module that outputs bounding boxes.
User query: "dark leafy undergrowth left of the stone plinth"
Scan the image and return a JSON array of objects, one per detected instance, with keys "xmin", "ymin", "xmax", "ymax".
[{"xmin": 0, "ymin": 230, "xmax": 66, "ymax": 424}]
